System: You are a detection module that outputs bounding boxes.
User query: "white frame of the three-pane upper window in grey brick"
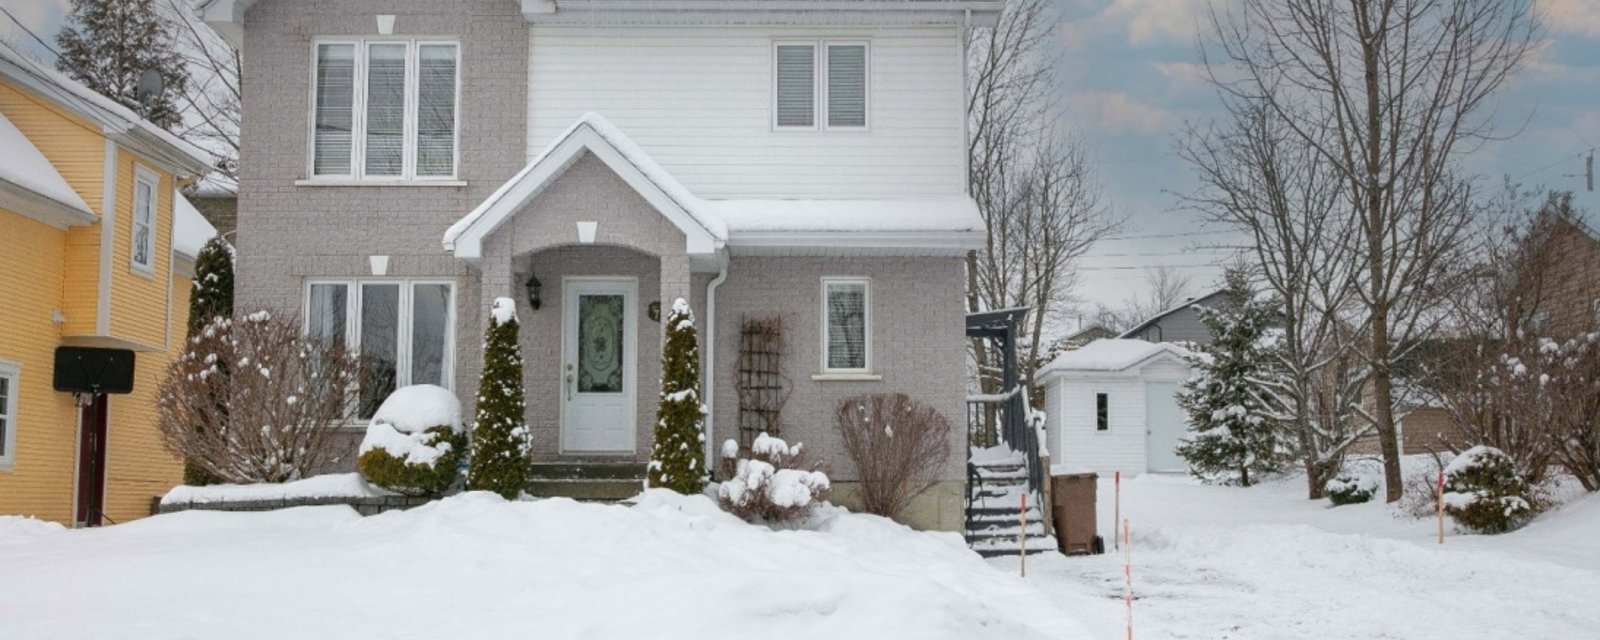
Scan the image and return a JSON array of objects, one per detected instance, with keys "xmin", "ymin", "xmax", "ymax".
[{"xmin": 306, "ymin": 37, "xmax": 462, "ymax": 184}]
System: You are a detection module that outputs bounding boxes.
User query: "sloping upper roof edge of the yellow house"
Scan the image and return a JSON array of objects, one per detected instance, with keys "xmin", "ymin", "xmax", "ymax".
[{"xmin": 0, "ymin": 40, "xmax": 211, "ymax": 176}]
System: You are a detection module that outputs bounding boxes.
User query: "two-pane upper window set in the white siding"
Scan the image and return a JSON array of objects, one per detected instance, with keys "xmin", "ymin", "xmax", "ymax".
[{"xmin": 773, "ymin": 42, "xmax": 869, "ymax": 130}]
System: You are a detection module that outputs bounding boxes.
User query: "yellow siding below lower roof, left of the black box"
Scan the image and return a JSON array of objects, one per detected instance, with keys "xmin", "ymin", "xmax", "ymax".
[{"xmin": 0, "ymin": 210, "xmax": 78, "ymax": 522}]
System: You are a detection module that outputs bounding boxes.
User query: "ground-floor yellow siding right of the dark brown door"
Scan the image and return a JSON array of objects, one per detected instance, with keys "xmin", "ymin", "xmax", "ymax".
[{"xmin": 106, "ymin": 275, "xmax": 190, "ymax": 522}]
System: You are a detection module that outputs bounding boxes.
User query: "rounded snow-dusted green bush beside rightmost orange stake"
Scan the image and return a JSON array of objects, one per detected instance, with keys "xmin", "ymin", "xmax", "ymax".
[{"xmin": 1445, "ymin": 445, "xmax": 1534, "ymax": 533}]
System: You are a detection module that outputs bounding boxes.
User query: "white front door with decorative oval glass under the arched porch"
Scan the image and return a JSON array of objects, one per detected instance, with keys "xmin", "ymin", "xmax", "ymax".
[{"xmin": 562, "ymin": 278, "xmax": 638, "ymax": 453}]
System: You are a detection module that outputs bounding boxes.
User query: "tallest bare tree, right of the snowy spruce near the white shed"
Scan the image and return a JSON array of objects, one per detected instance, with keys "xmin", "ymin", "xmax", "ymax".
[{"xmin": 1205, "ymin": 0, "xmax": 1536, "ymax": 501}]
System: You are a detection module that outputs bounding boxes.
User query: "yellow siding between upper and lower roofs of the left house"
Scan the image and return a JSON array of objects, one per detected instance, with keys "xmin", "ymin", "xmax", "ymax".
[{"xmin": 0, "ymin": 78, "xmax": 106, "ymax": 336}]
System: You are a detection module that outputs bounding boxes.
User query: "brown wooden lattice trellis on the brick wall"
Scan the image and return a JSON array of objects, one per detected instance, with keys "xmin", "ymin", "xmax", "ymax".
[{"xmin": 734, "ymin": 317, "xmax": 790, "ymax": 451}]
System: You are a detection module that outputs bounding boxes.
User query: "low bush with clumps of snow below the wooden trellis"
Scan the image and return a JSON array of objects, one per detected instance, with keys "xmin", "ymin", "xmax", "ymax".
[{"xmin": 717, "ymin": 434, "xmax": 832, "ymax": 523}]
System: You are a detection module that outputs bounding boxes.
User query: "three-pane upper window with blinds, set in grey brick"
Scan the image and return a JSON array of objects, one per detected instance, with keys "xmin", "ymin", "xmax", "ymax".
[{"xmin": 310, "ymin": 40, "xmax": 461, "ymax": 179}]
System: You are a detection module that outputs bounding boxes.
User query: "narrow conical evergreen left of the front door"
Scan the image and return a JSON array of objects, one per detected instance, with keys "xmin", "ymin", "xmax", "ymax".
[{"xmin": 467, "ymin": 298, "xmax": 528, "ymax": 499}]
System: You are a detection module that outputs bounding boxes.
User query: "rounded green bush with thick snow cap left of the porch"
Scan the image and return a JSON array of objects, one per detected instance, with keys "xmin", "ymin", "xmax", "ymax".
[{"xmin": 358, "ymin": 384, "xmax": 467, "ymax": 496}]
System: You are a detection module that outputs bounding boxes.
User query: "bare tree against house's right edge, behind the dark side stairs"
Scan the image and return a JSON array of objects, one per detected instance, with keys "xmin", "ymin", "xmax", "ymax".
[{"xmin": 966, "ymin": 0, "xmax": 1117, "ymax": 392}]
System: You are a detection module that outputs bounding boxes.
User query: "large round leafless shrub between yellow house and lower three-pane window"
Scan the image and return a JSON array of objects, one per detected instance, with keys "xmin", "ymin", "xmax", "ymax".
[{"xmin": 158, "ymin": 310, "xmax": 358, "ymax": 483}]
